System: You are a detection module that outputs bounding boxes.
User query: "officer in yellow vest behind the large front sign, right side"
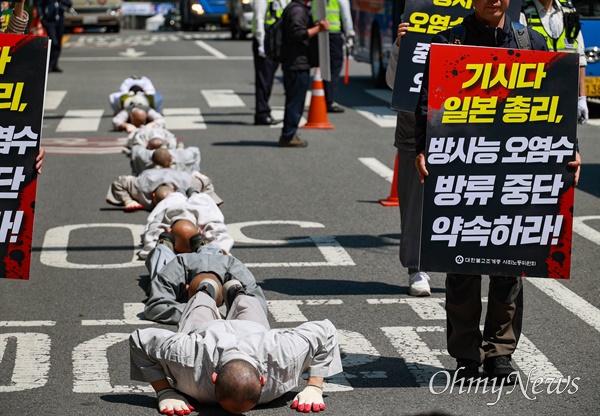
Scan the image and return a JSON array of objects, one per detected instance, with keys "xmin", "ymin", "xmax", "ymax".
[{"xmin": 520, "ymin": 0, "xmax": 589, "ymax": 124}]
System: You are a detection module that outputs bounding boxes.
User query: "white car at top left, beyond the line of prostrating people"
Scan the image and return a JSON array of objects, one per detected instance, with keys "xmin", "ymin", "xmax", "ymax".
[{"xmin": 65, "ymin": 0, "xmax": 121, "ymax": 33}]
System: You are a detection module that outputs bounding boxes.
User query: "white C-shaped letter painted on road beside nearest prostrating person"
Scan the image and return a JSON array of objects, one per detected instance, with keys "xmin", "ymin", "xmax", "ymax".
[{"xmin": 72, "ymin": 333, "xmax": 154, "ymax": 393}]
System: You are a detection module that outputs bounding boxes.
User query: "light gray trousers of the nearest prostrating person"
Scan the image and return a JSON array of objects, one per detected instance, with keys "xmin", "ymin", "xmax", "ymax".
[{"xmin": 177, "ymin": 292, "xmax": 271, "ymax": 334}]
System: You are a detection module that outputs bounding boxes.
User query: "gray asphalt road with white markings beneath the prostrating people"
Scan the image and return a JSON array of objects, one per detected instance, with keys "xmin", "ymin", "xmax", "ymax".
[{"xmin": 0, "ymin": 31, "xmax": 600, "ymax": 415}]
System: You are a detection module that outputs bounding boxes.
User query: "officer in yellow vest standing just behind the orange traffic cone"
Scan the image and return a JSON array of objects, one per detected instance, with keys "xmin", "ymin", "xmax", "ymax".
[{"xmin": 312, "ymin": 0, "xmax": 355, "ymax": 113}]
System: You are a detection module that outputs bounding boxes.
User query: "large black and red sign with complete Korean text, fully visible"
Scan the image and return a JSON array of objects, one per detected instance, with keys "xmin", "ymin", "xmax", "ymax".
[{"xmin": 420, "ymin": 44, "xmax": 579, "ymax": 279}]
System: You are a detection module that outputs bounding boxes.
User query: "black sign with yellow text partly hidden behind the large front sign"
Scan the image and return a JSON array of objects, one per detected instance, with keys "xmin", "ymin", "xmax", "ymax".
[{"xmin": 391, "ymin": 0, "xmax": 521, "ymax": 111}]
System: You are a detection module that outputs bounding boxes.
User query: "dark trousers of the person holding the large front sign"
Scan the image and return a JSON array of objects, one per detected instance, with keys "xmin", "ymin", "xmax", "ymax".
[{"xmin": 446, "ymin": 273, "xmax": 523, "ymax": 363}]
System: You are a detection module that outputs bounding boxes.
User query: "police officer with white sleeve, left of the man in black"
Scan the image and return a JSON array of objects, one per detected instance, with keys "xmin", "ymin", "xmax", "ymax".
[{"xmin": 252, "ymin": 0, "xmax": 290, "ymax": 126}]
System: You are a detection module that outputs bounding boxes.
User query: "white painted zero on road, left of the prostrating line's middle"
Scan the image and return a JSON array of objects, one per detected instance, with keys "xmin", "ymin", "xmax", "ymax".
[{"xmin": 40, "ymin": 223, "xmax": 144, "ymax": 269}]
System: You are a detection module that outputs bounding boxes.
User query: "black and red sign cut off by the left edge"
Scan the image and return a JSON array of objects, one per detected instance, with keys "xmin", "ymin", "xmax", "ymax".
[{"xmin": 0, "ymin": 34, "xmax": 49, "ymax": 280}]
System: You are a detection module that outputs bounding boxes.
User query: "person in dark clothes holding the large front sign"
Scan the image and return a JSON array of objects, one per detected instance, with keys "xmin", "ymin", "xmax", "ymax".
[{"xmin": 415, "ymin": 0, "xmax": 581, "ymax": 383}]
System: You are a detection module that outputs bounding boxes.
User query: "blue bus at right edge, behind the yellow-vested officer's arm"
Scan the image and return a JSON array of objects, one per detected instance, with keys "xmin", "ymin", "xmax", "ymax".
[{"xmin": 572, "ymin": 0, "xmax": 600, "ymax": 99}]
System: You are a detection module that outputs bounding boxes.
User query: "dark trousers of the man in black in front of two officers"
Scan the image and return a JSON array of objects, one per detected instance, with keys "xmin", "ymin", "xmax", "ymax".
[{"xmin": 281, "ymin": 69, "xmax": 310, "ymax": 140}]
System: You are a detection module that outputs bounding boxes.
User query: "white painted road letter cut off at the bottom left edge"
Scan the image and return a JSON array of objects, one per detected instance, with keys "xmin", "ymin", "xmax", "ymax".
[{"xmin": 0, "ymin": 332, "xmax": 50, "ymax": 393}]
